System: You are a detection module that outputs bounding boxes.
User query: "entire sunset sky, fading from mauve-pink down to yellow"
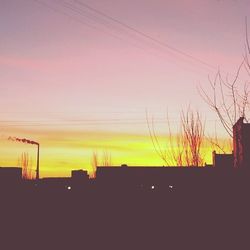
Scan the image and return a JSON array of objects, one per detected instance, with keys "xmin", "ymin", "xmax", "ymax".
[{"xmin": 0, "ymin": 0, "xmax": 250, "ymax": 176}]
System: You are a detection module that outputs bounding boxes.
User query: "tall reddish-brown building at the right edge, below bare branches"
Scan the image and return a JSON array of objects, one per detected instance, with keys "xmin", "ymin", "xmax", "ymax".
[{"xmin": 233, "ymin": 117, "xmax": 250, "ymax": 168}]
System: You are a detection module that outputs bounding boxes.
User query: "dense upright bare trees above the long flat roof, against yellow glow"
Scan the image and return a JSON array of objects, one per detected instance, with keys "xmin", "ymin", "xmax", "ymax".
[{"xmin": 147, "ymin": 109, "xmax": 205, "ymax": 166}]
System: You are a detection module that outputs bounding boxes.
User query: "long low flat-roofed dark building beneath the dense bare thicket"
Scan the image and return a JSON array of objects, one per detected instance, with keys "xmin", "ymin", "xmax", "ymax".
[{"xmin": 96, "ymin": 166, "xmax": 216, "ymax": 192}]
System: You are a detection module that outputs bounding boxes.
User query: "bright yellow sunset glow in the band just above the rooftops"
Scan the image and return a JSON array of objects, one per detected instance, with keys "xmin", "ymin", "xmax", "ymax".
[{"xmin": 0, "ymin": 129, "xmax": 230, "ymax": 178}]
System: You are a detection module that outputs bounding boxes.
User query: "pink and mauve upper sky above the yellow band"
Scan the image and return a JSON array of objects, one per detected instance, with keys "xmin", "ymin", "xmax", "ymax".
[{"xmin": 0, "ymin": 0, "xmax": 250, "ymax": 176}]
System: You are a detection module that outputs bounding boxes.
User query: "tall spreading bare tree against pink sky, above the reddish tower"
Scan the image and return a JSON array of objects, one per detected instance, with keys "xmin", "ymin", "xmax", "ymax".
[{"xmin": 198, "ymin": 19, "xmax": 250, "ymax": 138}]
